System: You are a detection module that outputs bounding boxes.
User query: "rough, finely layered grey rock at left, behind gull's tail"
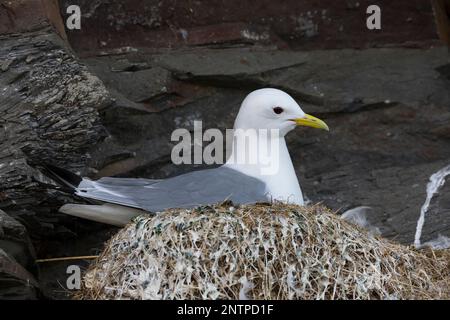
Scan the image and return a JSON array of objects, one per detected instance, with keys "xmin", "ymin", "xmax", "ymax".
[{"xmin": 0, "ymin": 32, "xmax": 111, "ymax": 235}]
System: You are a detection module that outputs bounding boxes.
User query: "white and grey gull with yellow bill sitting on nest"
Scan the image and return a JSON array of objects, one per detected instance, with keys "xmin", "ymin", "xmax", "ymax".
[{"xmin": 51, "ymin": 88, "xmax": 328, "ymax": 226}]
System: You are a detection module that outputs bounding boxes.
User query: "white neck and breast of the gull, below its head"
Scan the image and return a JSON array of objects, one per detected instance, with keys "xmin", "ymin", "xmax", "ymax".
[{"xmin": 225, "ymin": 131, "xmax": 303, "ymax": 205}]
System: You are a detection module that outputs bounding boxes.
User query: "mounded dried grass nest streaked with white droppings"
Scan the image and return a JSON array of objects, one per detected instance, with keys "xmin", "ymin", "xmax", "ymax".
[{"xmin": 76, "ymin": 203, "xmax": 450, "ymax": 299}]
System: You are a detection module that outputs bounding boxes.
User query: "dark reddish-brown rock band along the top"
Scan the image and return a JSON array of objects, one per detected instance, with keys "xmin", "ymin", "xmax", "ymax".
[{"xmin": 60, "ymin": 0, "xmax": 437, "ymax": 55}]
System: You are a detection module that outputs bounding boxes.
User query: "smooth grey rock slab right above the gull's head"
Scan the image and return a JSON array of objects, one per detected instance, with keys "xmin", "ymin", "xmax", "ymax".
[{"xmin": 155, "ymin": 47, "xmax": 448, "ymax": 113}]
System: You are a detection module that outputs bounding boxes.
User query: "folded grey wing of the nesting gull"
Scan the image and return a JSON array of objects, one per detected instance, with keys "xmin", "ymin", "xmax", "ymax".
[{"xmin": 77, "ymin": 167, "xmax": 267, "ymax": 212}]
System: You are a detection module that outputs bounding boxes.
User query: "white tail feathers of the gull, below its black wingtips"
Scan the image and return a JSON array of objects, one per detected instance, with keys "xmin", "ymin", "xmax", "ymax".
[{"xmin": 59, "ymin": 203, "xmax": 148, "ymax": 227}]
